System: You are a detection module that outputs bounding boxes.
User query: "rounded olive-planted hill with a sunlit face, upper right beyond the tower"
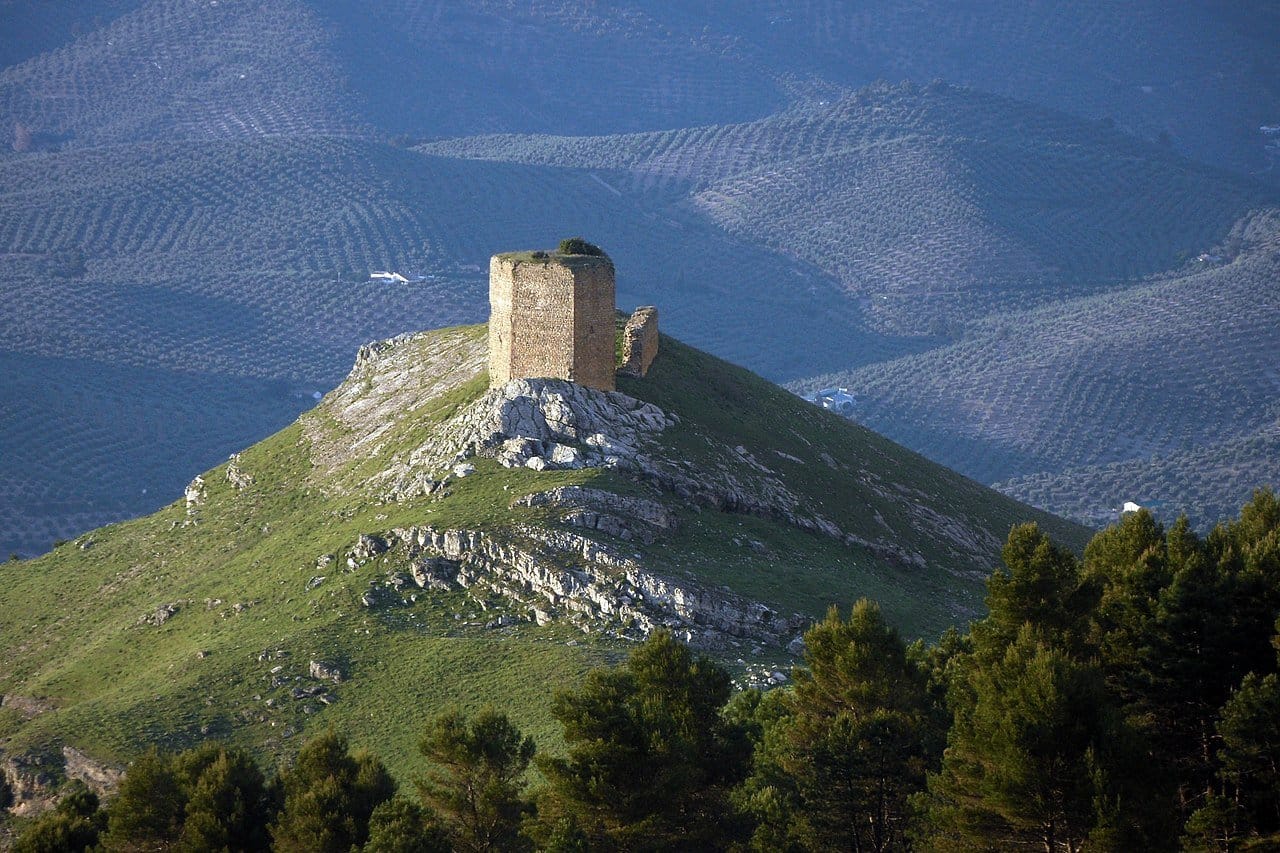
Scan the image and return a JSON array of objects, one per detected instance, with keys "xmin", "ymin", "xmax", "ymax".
[{"xmin": 420, "ymin": 85, "xmax": 1280, "ymax": 336}]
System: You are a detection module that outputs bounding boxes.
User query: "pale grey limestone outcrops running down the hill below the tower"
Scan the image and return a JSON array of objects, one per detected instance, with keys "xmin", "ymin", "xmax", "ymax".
[{"xmin": 294, "ymin": 327, "xmax": 1024, "ymax": 651}]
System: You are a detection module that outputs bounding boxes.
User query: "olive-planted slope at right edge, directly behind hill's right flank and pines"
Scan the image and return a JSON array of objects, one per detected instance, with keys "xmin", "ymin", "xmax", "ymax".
[{"xmin": 806, "ymin": 211, "xmax": 1280, "ymax": 525}]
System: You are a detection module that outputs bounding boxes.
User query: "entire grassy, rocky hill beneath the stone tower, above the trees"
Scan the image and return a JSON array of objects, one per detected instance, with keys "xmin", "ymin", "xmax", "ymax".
[{"xmin": 0, "ymin": 327, "xmax": 1087, "ymax": 777}]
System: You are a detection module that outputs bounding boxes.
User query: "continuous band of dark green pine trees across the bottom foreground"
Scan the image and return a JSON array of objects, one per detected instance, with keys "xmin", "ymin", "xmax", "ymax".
[{"xmin": 15, "ymin": 492, "xmax": 1280, "ymax": 853}]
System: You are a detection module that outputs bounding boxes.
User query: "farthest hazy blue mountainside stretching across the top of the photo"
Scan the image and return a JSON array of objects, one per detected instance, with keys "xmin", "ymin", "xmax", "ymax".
[{"xmin": 0, "ymin": 0, "xmax": 1280, "ymax": 177}]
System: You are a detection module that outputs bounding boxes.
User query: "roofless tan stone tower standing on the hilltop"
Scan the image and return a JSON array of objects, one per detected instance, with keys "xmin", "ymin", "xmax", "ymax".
[{"xmin": 489, "ymin": 252, "xmax": 616, "ymax": 391}]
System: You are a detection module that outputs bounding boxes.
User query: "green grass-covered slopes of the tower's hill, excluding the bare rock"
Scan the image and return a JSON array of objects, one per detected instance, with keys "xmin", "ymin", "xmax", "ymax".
[{"xmin": 0, "ymin": 327, "xmax": 1087, "ymax": 772}]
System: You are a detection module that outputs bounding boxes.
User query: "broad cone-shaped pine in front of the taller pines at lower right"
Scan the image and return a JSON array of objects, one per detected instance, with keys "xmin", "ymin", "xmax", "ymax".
[{"xmin": 922, "ymin": 624, "xmax": 1143, "ymax": 852}]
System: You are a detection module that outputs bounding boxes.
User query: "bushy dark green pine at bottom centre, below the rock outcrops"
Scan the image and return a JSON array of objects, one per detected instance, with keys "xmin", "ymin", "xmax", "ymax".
[{"xmin": 539, "ymin": 631, "xmax": 750, "ymax": 850}]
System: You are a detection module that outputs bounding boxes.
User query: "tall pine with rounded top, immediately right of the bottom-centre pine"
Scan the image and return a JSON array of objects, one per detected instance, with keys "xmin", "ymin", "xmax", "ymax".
[{"xmin": 745, "ymin": 599, "xmax": 946, "ymax": 850}]
